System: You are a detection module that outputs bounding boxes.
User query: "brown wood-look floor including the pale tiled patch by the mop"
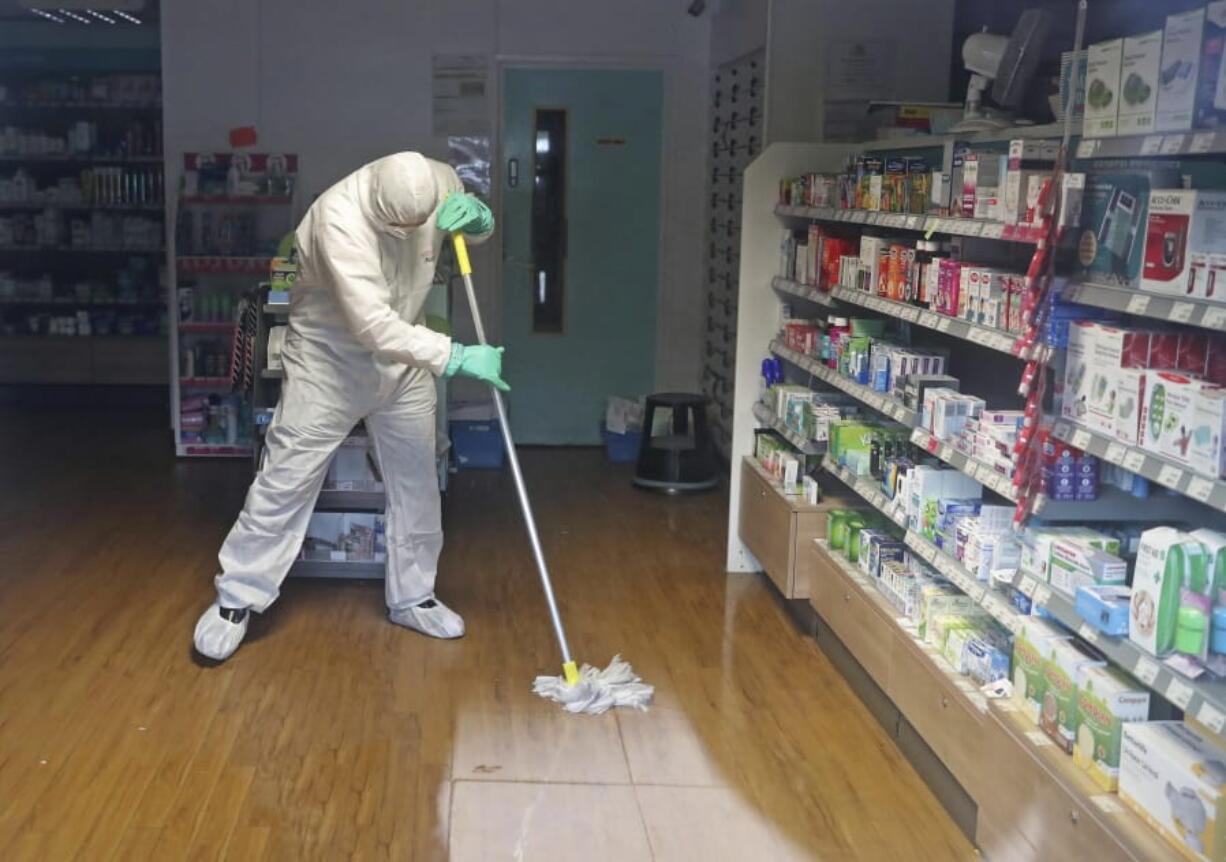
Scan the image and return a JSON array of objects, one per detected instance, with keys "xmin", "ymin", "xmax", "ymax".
[{"xmin": 0, "ymin": 408, "xmax": 975, "ymax": 862}]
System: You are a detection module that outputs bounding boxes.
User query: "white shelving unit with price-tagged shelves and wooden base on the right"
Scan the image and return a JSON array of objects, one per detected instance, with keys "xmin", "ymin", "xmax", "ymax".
[{"xmin": 727, "ymin": 121, "xmax": 1226, "ymax": 860}]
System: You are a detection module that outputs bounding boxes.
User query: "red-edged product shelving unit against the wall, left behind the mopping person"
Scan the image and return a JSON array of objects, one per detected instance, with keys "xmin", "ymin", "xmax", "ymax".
[{"xmin": 169, "ymin": 153, "xmax": 298, "ymax": 457}]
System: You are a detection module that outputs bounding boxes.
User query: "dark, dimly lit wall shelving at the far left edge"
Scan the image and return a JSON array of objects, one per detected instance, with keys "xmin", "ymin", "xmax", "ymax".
[{"xmin": 0, "ymin": 69, "xmax": 167, "ymax": 384}]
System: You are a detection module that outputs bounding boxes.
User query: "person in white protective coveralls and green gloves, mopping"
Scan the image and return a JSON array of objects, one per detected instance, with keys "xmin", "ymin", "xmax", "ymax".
[{"xmin": 195, "ymin": 152, "xmax": 508, "ymax": 661}]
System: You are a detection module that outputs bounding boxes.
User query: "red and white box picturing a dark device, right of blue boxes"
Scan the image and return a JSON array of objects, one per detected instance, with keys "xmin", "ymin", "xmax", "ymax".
[{"xmin": 1141, "ymin": 189, "xmax": 1226, "ymax": 299}]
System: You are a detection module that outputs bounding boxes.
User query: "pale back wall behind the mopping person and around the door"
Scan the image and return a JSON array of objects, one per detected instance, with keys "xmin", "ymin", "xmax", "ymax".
[{"xmin": 162, "ymin": 0, "xmax": 710, "ymax": 389}]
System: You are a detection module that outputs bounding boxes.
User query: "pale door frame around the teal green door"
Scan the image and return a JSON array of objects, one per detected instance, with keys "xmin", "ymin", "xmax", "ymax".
[{"xmin": 485, "ymin": 54, "xmax": 680, "ymax": 375}]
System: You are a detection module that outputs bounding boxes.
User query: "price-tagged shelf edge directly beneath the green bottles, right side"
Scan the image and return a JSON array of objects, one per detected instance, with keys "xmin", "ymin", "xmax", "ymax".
[{"xmin": 1014, "ymin": 571, "xmax": 1226, "ymax": 736}]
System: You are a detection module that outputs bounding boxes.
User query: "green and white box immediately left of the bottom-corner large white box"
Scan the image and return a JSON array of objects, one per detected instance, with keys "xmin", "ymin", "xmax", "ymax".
[{"xmin": 1073, "ymin": 665, "xmax": 1150, "ymax": 793}]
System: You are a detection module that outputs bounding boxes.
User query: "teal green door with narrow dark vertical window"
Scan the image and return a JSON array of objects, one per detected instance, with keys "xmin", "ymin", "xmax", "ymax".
[{"xmin": 500, "ymin": 69, "xmax": 662, "ymax": 445}]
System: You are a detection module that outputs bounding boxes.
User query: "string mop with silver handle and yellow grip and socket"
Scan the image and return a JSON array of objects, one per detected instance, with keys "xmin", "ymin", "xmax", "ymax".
[{"xmin": 451, "ymin": 232, "xmax": 655, "ymax": 715}]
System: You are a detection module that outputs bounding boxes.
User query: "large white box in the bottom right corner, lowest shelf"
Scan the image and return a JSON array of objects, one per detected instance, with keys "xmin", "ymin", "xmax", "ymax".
[{"xmin": 1119, "ymin": 721, "xmax": 1226, "ymax": 862}]
